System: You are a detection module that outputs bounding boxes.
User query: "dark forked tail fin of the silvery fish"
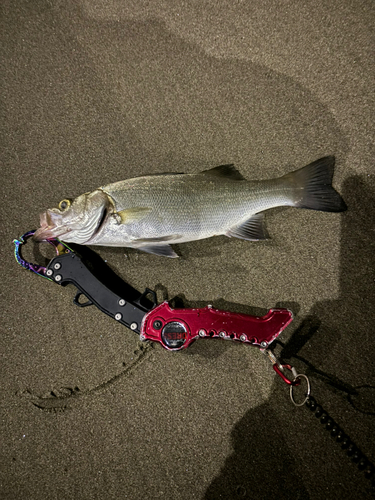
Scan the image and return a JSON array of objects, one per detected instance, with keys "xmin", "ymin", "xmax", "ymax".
[{"xmin": 282, "ymin": 156, "xmax": 347, "ymax": 212}]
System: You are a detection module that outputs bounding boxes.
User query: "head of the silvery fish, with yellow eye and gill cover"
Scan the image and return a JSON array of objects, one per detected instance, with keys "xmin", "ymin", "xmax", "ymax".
[{"xmin": 34, "ymin": 189, "xmax": 112, "ymax": 245}]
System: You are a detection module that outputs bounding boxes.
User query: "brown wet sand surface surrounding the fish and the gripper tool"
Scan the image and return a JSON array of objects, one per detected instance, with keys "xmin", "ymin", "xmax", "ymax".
[{"xmin": 0, "ymin": 0, "xmax": 375, "ymax": 500}]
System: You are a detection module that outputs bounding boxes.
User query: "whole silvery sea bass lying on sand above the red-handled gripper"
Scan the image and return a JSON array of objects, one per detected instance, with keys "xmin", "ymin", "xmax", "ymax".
[{"xmin": 34, "ymin": 156, "xmax": 346, "ymax": 257}]
